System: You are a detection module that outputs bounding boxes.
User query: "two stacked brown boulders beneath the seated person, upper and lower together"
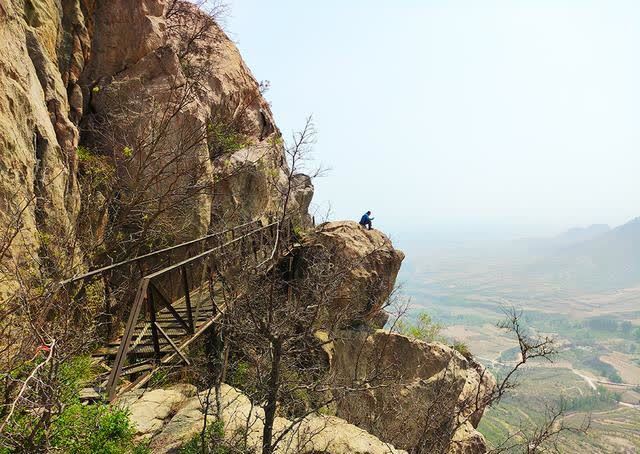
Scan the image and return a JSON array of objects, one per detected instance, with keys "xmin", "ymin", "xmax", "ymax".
[{"xmin": 303, "ymin": 221, "xmax": 495, "ymax": 453}]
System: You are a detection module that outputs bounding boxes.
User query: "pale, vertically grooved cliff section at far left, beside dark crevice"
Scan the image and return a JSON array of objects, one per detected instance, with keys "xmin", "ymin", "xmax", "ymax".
[{"xmin": 0, "ymin": 0, "xmax": 89, "ymax": 290}]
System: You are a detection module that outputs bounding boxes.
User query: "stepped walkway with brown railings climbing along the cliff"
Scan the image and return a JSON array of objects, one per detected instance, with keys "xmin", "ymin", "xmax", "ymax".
[{"xmin": 63, "ymin": 222, "xmax": 291, "ymax": 400}]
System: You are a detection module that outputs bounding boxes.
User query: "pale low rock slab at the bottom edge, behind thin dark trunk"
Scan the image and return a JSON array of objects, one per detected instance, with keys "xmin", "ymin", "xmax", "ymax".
[{"xmin": 121, "ymin": 385, "xmax": 404, "ymax": 454}]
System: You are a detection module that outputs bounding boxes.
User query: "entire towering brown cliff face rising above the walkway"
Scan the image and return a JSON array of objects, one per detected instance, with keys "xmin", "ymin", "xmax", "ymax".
[{"xmin": 0, "ymin": 0, "xmax": 313, "ymax": 294}]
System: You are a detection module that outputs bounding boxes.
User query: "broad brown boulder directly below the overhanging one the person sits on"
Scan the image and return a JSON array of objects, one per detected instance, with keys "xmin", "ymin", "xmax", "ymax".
[{"xmin": 331, "ymin": 330, "xmax": 495, "ymax": 453}]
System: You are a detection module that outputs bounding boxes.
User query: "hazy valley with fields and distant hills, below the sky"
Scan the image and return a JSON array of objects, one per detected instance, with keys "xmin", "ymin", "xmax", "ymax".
[{"xmin": 398, "ymin": 218, "xmax": 640, "ymax": 453}]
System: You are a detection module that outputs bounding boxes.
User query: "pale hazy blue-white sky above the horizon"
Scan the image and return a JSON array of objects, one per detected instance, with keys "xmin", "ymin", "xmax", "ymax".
[{"xmin": 226, "ymin": 0, "xmax": 640, "ymax": 238}]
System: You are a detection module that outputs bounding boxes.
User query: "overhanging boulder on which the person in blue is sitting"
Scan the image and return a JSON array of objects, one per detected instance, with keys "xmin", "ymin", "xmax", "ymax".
[{"xmin": 301, "ymin": 221, "xmax": 404, "ymax": 326}]
